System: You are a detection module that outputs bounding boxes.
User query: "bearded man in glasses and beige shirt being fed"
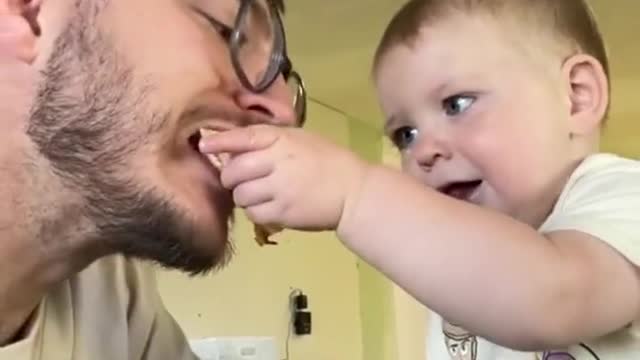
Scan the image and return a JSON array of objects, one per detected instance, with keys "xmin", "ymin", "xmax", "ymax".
[{"xmin": 0, "ymin": 0, "xmax": 304, "ymax": 360}]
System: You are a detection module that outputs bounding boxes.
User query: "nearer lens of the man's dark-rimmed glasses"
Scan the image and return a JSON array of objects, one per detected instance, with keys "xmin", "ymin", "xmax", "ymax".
[{"xmin": 233, "ymin": 0, "xmax": 276, "ymax": 90}]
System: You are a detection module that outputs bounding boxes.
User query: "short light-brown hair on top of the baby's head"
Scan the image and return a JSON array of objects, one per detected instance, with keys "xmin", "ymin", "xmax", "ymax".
[{"xmin": 374, "ymin": 0, "xmax": 609, "ymax": 77}]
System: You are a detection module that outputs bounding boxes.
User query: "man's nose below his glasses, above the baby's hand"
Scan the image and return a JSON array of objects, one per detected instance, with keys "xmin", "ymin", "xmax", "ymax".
[{"xmin": 237, "ymin": 76, "xmax": 297, "ymax": 126}]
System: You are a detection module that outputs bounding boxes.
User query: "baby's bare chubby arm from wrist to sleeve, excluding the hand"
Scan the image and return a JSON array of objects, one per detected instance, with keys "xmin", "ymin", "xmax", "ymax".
[{"xmin": 338, "ymin": 163, "xmax": 640, "ymax": 350}]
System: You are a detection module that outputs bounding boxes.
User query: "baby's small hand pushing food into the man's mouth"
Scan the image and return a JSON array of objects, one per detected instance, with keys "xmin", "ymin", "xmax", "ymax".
[{"xmin": 200, "ymin": 125, "xmax": 369, "ymax": 231}]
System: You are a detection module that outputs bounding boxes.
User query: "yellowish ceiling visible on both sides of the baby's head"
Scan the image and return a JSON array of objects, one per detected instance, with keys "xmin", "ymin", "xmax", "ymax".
[{"xmin": 285, "ymin": 0, "xmax": 640, "ymax": 134}]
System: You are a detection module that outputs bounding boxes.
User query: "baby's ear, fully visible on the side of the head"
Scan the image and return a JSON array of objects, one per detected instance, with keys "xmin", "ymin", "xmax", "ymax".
[{"xmin": 563, "ymin": 54, "xmax": 609, "ymax": 135}]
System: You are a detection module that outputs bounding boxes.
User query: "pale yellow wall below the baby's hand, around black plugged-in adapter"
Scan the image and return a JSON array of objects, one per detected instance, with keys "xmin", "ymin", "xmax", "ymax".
[{"xmin": 159, "ymin": 101, "xmax": 363, "ymax": 360}]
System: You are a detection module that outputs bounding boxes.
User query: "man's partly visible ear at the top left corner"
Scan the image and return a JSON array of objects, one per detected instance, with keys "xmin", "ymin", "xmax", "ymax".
[{"xmin": 0, "ymin": 0, "xmax": 42, "ymax": 63}]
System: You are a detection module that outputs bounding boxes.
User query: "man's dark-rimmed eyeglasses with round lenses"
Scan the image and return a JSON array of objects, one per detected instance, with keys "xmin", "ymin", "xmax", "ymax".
[{"xmin": 220, "ymin": 0, "xmax": 307, "ymax": 126}]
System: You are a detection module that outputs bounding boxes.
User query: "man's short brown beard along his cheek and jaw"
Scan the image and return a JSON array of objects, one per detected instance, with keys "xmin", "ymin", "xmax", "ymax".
[{"xmin": 27, "ymin": 1, "xmax": 231, "ymax": 275}]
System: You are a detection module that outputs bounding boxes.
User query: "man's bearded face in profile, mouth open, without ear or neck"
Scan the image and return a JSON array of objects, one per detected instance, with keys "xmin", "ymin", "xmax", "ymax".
[{"xmin": 27, "ymin": 0, "xmax": 295, "ymax": 274}]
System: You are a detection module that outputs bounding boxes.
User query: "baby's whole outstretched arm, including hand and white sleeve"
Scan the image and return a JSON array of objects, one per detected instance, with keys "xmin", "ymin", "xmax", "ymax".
[{"xmin": 200, "ymin": 126, "xmax": 640, "ymax": 350}]
